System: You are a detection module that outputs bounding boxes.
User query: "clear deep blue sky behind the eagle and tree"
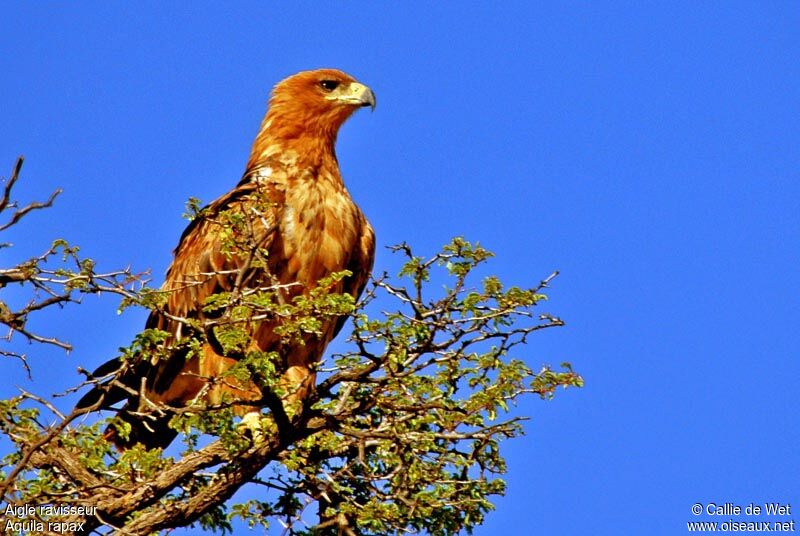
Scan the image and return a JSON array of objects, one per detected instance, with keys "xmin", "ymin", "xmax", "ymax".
[{"xmin": 0, "ymin": 1, "xmax": 800, "ymax": 535}]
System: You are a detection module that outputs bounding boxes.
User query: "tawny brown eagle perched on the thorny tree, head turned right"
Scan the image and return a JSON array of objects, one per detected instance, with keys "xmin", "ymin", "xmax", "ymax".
[{"xmin": 77, "ymin": 69, "xmax": 375, "ymax": 449}]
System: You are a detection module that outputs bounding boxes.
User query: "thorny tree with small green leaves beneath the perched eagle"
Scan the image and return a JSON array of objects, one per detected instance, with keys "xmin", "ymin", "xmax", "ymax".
[{"xmin": 0, "ymin": 159, "xmax": 582, "ymax": 535}]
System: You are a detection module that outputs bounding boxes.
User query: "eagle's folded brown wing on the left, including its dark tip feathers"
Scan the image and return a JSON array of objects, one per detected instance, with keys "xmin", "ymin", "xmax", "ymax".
[{"xmin": 76, "ymin": 181, "xmax": 283, "ymax": 411}]
